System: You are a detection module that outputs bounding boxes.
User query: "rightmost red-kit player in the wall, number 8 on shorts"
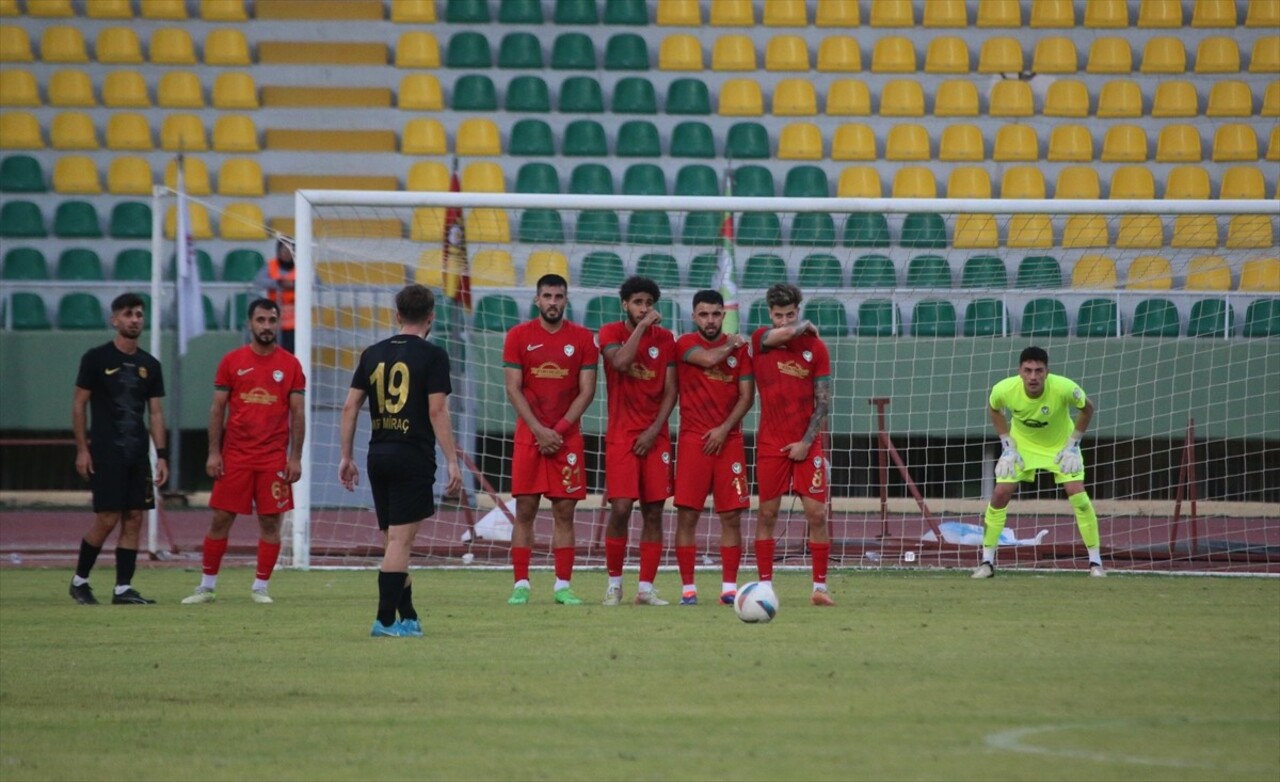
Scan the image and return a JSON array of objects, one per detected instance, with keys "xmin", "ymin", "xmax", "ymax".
[{"xmin": 751, "ymin": 283, "xmax": 835, "ymax": 605}]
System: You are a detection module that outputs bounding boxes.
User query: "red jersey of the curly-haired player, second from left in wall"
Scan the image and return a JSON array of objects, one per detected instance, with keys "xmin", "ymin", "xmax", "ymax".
[{"xmin": 598, "ymin": 320, "xmax": 676, "ymax": 443}]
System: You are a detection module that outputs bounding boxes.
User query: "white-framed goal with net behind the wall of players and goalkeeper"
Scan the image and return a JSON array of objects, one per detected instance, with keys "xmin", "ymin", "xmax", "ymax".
[{"xmin": 288, "ymin": 189, "xmax": 1280, "ymax": 571}]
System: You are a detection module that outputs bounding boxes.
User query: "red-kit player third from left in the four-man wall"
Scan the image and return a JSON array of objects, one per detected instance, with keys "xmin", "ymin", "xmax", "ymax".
[{"xmin": 676, "ymin": 291, "xmax": 755, "ymax": 605}]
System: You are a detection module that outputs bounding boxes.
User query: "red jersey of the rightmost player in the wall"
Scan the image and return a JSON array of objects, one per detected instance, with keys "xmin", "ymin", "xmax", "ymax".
[{"xmin": 751, "ymin": 326, "xmax": 831, "ymax": 448}]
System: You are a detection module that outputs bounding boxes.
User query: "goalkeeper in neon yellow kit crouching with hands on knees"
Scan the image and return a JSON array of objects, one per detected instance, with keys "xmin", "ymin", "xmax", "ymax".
[{"xmin": 973, "ymin": 347, "xmax": 1106, "ymax": 579}]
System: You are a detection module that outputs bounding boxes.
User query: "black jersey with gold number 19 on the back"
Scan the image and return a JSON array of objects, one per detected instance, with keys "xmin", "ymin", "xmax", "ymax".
[{"xmin": 351, "ymin": 334, "xmax": 453, "ymax": 454}]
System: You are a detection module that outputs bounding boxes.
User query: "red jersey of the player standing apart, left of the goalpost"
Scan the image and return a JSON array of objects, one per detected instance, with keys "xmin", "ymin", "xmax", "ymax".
[{"xmin": 214, "ymin": 346, "xmax": 307, "ymax": 470}]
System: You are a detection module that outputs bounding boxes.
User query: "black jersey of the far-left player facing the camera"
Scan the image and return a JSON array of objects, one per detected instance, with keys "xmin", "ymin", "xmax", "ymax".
[{"xmin": 76, "ymin": 342, "xmax": 164, "ymax": 459}]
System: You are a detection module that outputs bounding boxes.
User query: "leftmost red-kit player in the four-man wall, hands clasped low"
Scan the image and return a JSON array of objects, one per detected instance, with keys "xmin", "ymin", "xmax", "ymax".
[{"xmin": 502, "ymin": 274, "xmax": 600, "ymax": 605}]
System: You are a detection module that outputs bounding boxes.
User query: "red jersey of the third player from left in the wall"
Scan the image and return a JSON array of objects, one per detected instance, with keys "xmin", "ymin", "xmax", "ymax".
[{"xmin": 676, "ymin": 331, "xmax": 753, "ymax": 443}]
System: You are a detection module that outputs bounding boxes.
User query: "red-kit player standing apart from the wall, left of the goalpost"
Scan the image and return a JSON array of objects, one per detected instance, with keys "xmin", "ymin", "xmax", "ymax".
[{"xmin": 183, "ymin": 298, "xmax": 306, "ymax": 604}]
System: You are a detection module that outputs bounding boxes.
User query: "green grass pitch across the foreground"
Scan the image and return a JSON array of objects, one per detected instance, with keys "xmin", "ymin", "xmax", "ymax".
[{"xmin": 0, "ymin": 568, "xmax": 1280, "ymax": 782}]
